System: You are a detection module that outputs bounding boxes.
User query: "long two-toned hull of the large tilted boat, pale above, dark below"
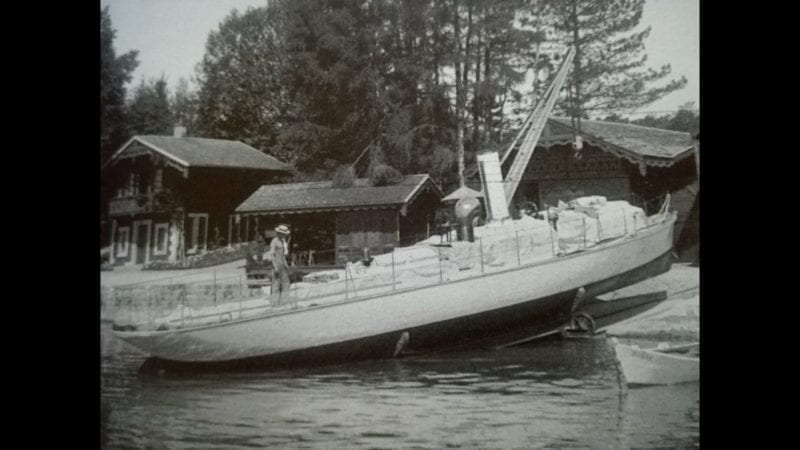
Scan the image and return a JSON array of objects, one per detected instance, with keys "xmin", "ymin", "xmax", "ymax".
[{"xmin": 115, "ymin": 215, "xmax": 675, "ymax": 368}]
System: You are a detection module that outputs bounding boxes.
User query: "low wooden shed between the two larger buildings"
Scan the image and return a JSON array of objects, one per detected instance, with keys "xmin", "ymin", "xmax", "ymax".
[{"xmin": 229, "ymin": 174, "xmax": 443, "ymax": 264}]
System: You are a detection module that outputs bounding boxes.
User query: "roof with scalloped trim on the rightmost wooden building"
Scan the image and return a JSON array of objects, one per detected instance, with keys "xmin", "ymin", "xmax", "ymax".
[{"xmin": 539, "ymin": 117, "xmax": 695, "ymax": 167}]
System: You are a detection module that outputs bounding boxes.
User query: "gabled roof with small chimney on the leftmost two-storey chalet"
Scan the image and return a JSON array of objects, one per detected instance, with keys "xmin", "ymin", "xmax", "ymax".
[{"xmin": 107, "ymin": 135, "xmax": 289, "ymax": 171}]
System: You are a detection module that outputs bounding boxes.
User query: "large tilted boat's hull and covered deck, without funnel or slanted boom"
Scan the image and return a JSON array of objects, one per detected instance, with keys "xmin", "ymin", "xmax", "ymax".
[{"xmin": 114, "ymin": 196, "xmax": 675, "ymax": 366}]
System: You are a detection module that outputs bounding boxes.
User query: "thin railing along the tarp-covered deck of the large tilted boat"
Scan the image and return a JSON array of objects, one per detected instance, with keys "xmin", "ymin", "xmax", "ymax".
[{"xmin": 111, "ymin": 195, "xmax": 669, "ymax": 330}]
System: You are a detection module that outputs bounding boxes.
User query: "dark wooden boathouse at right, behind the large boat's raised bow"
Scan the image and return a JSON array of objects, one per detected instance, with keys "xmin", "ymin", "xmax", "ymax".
[{"xmin": 468, "ymin": 117, "xmax": 699, "ymax": 260}]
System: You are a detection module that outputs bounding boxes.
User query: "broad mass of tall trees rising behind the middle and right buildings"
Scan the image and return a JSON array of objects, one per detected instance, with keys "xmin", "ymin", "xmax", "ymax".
[{"xmin": 189, "ymin": 0, "xmax": 686, "ymax": 189}]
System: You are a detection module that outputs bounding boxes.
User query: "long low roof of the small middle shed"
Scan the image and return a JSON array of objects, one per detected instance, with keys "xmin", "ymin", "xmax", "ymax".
[{"xmin": 236, "ymin": 174, "xmax": 442, "ymax": 214}]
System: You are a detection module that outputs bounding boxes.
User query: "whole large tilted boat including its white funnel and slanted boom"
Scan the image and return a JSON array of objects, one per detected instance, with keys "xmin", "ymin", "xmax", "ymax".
[{"xmin": 113, "ymin": 45, "xmax": 676, "ymax": 368}]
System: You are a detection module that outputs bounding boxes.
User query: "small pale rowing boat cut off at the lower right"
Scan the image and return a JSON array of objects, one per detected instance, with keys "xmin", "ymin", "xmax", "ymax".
[{"xmin": 612, "ymin": 338, "xmax": 700, "ymax": 385}]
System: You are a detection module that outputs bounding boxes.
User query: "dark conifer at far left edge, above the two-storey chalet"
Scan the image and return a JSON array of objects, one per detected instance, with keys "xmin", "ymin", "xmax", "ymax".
[{"xmin": 100, "ymin": 6, "xmax": 139, "ymax": 164}]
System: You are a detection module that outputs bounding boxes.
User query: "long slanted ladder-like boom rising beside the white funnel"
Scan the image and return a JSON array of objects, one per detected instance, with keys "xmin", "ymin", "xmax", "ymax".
[{"xmin": 500, "ymin": 47, "xmax": 575, "ymax": 205}]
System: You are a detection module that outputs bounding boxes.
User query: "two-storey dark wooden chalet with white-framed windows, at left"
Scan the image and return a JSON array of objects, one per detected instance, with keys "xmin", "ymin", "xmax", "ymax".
[{"xmin": 101, "ymin": 127, "xmax": 289, "ymax": 265}]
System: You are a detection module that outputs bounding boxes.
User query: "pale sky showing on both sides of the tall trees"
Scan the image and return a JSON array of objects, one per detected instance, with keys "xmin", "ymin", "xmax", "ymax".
[{"xmin": 100, "ymin": 0, "xmax": 700, "ymax": 118}]
